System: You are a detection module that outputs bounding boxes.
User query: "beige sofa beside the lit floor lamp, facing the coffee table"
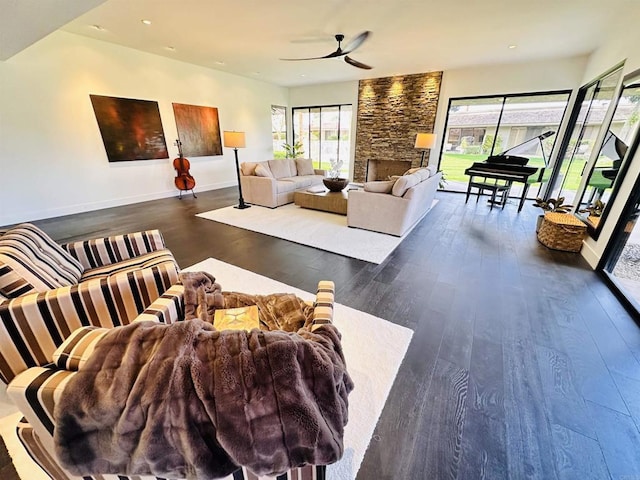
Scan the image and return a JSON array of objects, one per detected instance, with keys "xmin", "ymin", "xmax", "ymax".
[{"xmin": 240, "ymin": 158, "xmax": 325, "ymax": 208}]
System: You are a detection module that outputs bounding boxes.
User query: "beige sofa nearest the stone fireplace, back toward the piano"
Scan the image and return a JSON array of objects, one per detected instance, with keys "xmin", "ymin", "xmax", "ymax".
[{"xmin": 347, "ymin": 166, "xmax": 442, "ymax": 237}]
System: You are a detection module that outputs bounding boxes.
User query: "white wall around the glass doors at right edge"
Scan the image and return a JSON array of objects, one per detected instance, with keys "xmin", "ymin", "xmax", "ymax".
[{"xmin": 582, "ymin": 25, "xmax": 640, "ymax": 268}]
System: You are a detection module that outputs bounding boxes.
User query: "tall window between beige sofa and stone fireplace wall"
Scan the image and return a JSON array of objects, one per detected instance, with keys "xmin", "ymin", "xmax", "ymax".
[{"xmin": 293, "ymin": 105, "xmax": 352, "ymax": 177}]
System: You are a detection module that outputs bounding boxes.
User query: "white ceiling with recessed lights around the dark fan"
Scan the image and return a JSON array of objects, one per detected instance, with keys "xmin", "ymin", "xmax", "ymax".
[{"xmin": 0, "ymin": 0, "xmax": 640, "ymax": 86}]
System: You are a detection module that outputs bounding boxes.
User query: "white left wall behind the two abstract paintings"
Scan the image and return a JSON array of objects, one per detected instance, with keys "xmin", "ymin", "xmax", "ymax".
[{"xmin": 0, "ymin": 31, "xmax": 288, "ymax": 225}]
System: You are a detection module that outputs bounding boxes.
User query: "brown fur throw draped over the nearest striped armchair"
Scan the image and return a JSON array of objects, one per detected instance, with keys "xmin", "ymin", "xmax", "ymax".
[{"xmin": 54, "ymin": 277, "xmax": 353, "ymax": 479}]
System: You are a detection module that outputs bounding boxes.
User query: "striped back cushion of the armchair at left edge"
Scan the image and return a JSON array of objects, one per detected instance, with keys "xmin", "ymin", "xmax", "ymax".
[{"xmin": 0, "ymin": 223, "xmax": 84, "ymax": 298}]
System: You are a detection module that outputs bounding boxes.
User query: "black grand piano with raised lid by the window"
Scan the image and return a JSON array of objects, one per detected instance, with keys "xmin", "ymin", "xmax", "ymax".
[{"xmin": 464, "ymin": 130, "xmax": 555, "ymax": 212}]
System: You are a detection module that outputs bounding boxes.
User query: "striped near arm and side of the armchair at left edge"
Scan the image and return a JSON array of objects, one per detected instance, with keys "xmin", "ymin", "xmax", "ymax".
[{"xmin": 0, "ymin": 262, "xmax": 178, "ymax": 382}]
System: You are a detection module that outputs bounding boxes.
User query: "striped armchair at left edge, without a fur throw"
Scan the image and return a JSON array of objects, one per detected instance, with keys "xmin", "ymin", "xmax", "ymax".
[{"xmin": 0, "ymin": 223, "xmax": 178, "ymax": 383}]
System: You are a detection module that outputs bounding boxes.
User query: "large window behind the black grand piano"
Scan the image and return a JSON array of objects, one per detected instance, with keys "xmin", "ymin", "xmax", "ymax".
[{"xmin": 440, "ymin": 91, "xmax": 570, "ymax": 197}]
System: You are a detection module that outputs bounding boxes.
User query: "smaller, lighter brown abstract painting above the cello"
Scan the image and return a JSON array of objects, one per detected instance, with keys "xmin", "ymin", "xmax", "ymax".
[{"xmin": 173, "ymin": 103, "xmax": 222, "ymax": 157}]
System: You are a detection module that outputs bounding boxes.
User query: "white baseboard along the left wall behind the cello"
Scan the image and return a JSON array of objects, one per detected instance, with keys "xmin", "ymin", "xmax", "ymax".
[{"xmin": 0, "ymin": 182, "xmax": 237, "ymax": 225}]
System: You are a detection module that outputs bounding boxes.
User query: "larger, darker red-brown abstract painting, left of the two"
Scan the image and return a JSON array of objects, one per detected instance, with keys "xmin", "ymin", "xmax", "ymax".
[{"xmin": 89, "ymin": 95, "xmax": 169, "ymax": 162}]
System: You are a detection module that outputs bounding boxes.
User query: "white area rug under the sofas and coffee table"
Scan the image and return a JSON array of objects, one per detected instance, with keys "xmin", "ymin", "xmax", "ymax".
[{"xmin": 197, "ymin": 200, "xmax": 437, "ymax": 264}]
